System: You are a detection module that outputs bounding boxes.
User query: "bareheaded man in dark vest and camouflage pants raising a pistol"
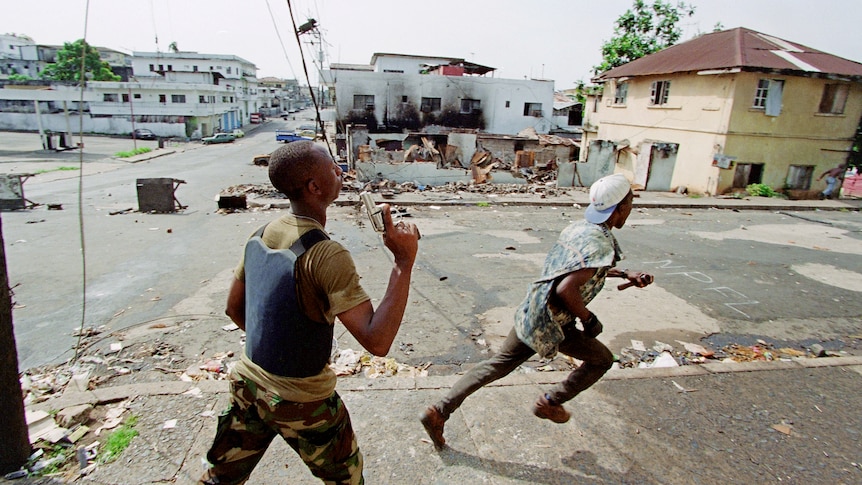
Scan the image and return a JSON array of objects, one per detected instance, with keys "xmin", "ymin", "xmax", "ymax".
[{"xmin": 198, "ymin": 141, "xmax": 419, "ymax": 485}]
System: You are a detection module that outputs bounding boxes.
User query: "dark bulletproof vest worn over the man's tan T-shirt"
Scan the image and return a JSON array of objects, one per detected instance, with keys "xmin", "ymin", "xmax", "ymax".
[{"xmin": 245, "ymin": 226, "xmax": 333, "ymax": 377}]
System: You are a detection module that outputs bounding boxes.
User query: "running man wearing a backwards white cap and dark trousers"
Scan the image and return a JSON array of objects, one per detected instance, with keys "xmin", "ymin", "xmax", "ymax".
[{"xmin": 419, "ymin": 174, "xmax": 653, "ymax": 449}]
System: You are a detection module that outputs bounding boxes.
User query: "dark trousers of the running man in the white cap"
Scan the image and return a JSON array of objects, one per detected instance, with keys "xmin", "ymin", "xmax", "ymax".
[{"xmin": 436, "ymin": 323, "xmax": 614, "ymax": 419}]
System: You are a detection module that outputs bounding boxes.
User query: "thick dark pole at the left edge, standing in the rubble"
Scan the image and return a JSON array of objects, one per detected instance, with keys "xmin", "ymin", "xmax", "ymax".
[{"xmin": 0, "ymin": 214, "xmax": 30, "ymax": 474}]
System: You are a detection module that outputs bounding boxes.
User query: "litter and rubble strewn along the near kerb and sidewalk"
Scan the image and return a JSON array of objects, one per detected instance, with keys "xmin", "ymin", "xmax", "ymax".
[{"xmin": 20, "ymin": 312, "xmax": 852, "ymax": 481}]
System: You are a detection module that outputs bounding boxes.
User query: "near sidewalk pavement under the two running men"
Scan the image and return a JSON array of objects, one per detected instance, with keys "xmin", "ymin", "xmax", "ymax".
[{"xmin": 25, "ymin": 357, "xmax": 862, "ymax": 485}]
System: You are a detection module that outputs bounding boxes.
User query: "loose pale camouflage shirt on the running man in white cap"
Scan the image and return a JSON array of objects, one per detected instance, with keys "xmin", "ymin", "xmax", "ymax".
[{"xmin": 515, "ymin": 221, "xmax": 624, "ymax": 358}]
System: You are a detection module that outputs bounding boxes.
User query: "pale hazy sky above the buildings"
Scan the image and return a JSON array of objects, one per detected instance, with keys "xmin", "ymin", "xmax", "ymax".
[{"xmin": 0, "ymin": 0, "xmax": 862, "ymax": 89}]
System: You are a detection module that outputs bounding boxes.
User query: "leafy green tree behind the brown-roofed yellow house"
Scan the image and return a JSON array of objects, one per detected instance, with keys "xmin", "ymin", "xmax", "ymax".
[{"xmin": 593, "ymin": 0, "xmax": 695, "ymax": 74}]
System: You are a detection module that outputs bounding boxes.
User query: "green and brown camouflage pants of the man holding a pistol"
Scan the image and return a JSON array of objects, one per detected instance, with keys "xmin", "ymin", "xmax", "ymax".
[{"xmin": 198, "ymin": 377, "xmax": 364, "ymax": 485}]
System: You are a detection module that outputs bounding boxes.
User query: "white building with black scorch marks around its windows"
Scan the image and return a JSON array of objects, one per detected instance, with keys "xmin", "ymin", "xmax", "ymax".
[{"xmin": 322, "ymin": 53, "xmax": 554, "ymax": 135}]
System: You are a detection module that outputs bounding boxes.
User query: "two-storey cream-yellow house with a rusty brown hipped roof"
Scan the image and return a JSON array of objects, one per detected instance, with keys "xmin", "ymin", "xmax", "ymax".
[{"xmin": 579, "ymin": 28, "xmax": 862, "ymax": 195}]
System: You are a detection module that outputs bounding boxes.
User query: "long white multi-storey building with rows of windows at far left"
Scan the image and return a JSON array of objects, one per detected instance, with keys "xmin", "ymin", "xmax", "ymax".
[{"xmin": 0, "ymin": 48, "xmax": 263, "ymax": 138}]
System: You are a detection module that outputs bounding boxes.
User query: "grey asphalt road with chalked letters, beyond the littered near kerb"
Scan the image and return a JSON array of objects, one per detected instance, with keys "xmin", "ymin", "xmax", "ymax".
[{"xmin": 0, "ymin": 120, "xmax": 862, "ymax": 374}]
